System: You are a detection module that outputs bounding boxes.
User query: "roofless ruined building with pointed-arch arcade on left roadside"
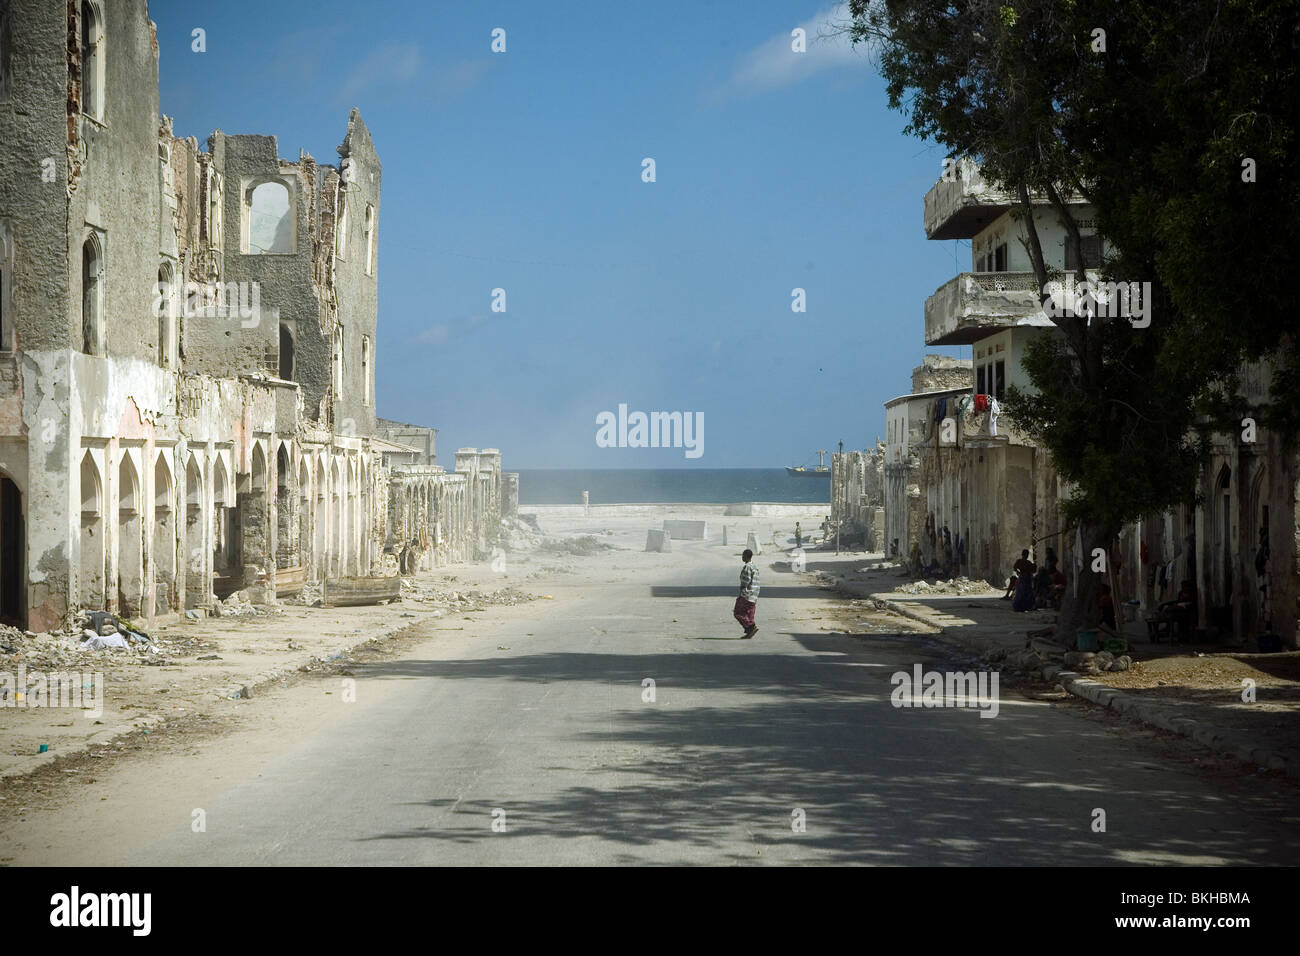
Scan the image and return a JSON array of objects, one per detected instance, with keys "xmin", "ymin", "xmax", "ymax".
[{"xmin": 0, "ymin": 0, "xmax": 517, "ymax": 631}]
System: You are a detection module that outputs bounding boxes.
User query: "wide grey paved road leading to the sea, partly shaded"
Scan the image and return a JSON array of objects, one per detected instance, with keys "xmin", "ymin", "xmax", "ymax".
[{"xmin": 129, "ymin": 545, "xmax": 1300, "ymax": 865}]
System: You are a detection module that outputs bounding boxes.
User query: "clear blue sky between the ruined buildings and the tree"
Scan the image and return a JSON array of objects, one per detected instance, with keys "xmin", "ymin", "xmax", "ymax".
[{"xmin": 150, "ymin": 0, "xmax": 970, "ymax": 470}]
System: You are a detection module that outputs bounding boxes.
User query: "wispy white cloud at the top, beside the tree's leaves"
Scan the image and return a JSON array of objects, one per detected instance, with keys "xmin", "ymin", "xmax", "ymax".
[{"xmin": 707, "ymin": 4, "xmax": 870, "ymax": 104}]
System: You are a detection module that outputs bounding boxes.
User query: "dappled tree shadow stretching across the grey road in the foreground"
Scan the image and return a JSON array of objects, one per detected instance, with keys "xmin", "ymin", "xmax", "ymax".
[{"xmin": 340, "ymin": 629, "xmax": 1297, "ymax": 865}]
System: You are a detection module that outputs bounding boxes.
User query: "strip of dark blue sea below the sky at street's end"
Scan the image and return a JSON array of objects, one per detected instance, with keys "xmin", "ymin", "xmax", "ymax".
[{"xmin": 519, "ymin": 468, "xmax": 831, "ymax": 507}]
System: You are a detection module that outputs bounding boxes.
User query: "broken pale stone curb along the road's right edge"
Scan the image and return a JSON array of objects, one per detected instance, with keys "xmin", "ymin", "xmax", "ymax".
[{"xmin": 840, "ymin": 583, "xmax": 1300, "ymax": 779}]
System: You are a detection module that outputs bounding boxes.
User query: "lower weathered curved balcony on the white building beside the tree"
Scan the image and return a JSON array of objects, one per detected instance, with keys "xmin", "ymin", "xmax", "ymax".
[{"xmin": 926, "ymin": 272, "xmax": 1053, "ymax": 345}]
